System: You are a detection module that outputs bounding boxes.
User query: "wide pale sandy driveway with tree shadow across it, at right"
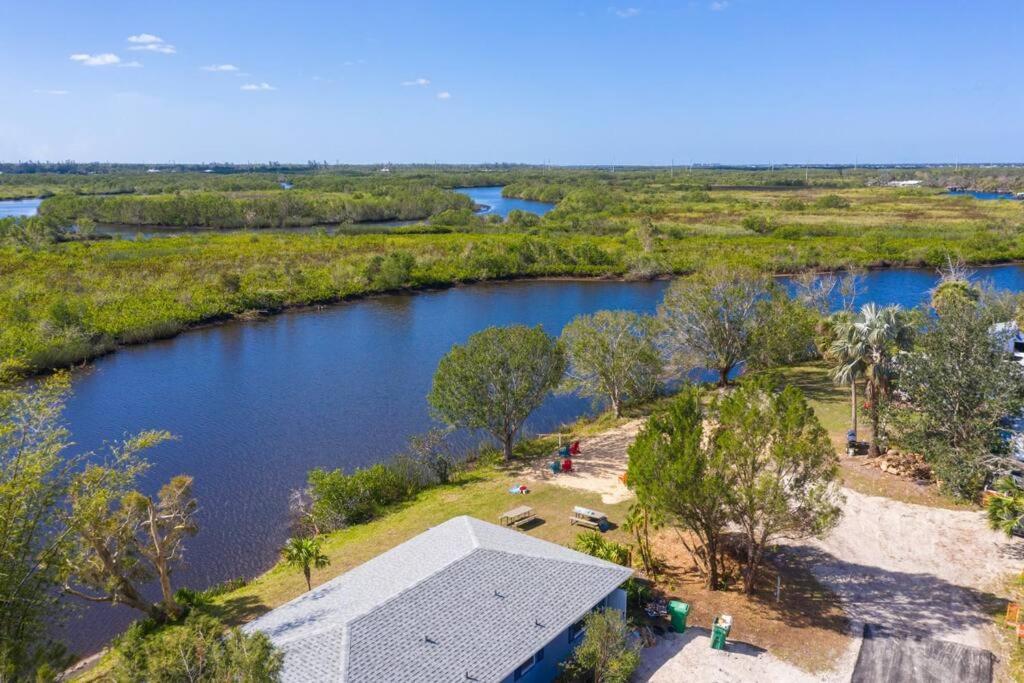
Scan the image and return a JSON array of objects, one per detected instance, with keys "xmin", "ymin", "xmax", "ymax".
[{"xmin": 788, "ymin": 489, "xmax": 1024, "ymax": 648}]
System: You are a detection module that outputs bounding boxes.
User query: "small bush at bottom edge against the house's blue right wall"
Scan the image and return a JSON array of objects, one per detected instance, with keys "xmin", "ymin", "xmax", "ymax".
[{"xmin": 563, "ymin": 609, "xmax": 640, "ymax": 683}]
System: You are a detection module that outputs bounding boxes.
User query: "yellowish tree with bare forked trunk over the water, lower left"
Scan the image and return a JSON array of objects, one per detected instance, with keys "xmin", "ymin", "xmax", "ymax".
[{"xmin": 63, "ymin": 431, "xmax": 198, "ymax": 621}]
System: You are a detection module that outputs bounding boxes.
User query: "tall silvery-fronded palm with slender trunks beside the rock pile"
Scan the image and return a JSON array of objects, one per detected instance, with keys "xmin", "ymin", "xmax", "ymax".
[{"xmin": 829, "ymin": 303, "xmax": 910, "ymax": 456}]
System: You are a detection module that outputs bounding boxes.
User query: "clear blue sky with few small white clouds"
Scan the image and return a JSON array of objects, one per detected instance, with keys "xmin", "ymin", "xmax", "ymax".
[{"xmin": 0, "ymin": 0, "xmax": 1024, "ymax": 164}]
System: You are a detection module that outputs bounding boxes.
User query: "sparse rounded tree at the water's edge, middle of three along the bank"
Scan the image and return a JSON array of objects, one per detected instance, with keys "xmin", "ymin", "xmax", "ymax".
[{"xmin": 561, "ymin": 310, "xmax": 662, "ymax": 418}]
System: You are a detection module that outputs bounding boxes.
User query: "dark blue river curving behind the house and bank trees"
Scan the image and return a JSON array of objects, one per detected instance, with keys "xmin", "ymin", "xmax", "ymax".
[{"xmin": 58, "ymin": 266, "xmax": 1024, "ymax": 651}]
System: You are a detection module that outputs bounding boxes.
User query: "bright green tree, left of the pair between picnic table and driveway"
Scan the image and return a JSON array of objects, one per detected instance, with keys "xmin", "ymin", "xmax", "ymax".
[{"xmin": 627, "ymin": 387, "xmax": 733, "ymax": 589}]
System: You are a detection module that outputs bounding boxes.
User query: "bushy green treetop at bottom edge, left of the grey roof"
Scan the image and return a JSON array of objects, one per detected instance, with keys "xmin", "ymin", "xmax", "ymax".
[{"xmin": 111, "ymin": 612, "xmax": 284, "ymax": 683}]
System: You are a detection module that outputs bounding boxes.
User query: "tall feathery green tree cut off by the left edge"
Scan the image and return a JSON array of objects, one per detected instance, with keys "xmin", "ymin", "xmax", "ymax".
[{"xmin": 0, "ymin": 374, "xmax": 80, "ymax": 681}]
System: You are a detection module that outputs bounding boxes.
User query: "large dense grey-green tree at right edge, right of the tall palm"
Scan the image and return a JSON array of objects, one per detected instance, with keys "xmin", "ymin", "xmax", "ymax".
[{"xmin": 896, "ymin": 298, "xmax": 1024, "ymax": 500}]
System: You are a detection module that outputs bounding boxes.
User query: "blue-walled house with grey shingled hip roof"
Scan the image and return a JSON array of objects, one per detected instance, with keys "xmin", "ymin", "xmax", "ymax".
[{"xmin": 246, "ymin": 516, "xmax": 632, "ymax": 683}]
